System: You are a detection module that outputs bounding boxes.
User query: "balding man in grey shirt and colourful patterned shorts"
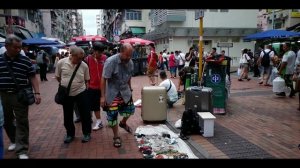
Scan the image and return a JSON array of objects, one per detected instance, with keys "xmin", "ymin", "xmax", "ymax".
[{"xmin": 100, "ymin": 44, "xmax": 135, "ymax": 147}]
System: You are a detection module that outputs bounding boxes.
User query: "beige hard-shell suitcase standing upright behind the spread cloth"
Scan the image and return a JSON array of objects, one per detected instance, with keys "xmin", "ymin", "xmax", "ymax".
[{"xmin": 141, "ymin": 86, "xmax": 167, "ymax": 122}]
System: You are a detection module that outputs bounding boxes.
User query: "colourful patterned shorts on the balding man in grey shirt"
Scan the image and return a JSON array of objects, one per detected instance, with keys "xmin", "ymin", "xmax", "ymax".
[{"xmin": 103, "ymin": 96, "xmax": 135, "ymax": 127}]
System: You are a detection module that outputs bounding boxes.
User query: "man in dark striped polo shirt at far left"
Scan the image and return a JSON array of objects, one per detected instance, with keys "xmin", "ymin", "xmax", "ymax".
[{"xmin": 0, "ymin": 35, "xmax": 41, "ymax": 159}]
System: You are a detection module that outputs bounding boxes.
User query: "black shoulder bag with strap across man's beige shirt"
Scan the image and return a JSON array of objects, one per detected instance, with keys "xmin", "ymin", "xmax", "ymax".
[{"xmin": 54, "ymin": 62, "xmax": 81, "ymax": 105}]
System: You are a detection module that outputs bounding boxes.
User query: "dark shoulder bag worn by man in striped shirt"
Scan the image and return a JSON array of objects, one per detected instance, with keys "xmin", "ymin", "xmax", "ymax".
[{"xmin": 3, "ymin": 56, "xmax": 35, "ymax": 105}]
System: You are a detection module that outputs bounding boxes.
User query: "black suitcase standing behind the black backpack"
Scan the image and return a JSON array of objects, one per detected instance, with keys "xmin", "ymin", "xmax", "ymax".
[{"xmin": 185, "ymin": 86, "xmax": 213, "ymax": 113}]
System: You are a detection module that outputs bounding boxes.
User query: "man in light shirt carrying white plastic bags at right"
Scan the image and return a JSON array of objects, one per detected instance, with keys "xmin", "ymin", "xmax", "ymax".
[{"xmin": 276, "ymin": 43, "xmax": 296, "ymax": 97}]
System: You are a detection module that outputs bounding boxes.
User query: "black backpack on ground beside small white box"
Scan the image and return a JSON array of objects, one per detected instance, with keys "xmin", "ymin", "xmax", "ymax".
[{"xmin": 180, "ymin": 109, "xmax": 201, "ymax": 137}]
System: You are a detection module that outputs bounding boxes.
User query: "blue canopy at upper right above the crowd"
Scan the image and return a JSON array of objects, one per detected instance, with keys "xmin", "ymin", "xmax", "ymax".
[{"xmin": 244, "ymin": 30, "xmax": 300, "ymax": 41}]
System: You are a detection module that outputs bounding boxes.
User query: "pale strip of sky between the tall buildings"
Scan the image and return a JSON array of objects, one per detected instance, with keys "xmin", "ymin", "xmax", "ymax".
[{"xmin": 81, "ymin": 10, "xmax": 100, "ymax": 35}]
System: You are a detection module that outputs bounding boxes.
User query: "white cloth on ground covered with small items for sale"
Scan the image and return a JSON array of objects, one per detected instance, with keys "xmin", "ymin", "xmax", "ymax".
[{"xmin": 135, "ymin": 125, "xmax": 197, "ymax": 159}]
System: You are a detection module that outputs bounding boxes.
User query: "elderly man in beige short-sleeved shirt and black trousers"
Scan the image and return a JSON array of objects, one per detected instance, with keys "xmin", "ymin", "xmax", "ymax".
[{"xmin": 55, "ymin": 47, "xmax": 92, "ymax": 143}]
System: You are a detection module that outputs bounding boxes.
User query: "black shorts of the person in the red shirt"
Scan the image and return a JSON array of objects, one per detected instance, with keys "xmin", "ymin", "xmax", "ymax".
[{"xmin": 87, "ymin": 88, "xmax": 101, "ymax": 111}]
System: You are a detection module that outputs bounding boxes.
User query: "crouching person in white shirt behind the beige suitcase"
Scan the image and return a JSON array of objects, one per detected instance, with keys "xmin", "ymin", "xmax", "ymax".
[{"xmin": 159, "ymin": 71, "xmax": 178, "ymax": 108}]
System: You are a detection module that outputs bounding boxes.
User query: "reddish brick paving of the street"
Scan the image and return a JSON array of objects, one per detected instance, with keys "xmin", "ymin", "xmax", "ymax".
[{"xmin": 4, "ymin": 71, "xmax": 300, "ymax": 158}]
